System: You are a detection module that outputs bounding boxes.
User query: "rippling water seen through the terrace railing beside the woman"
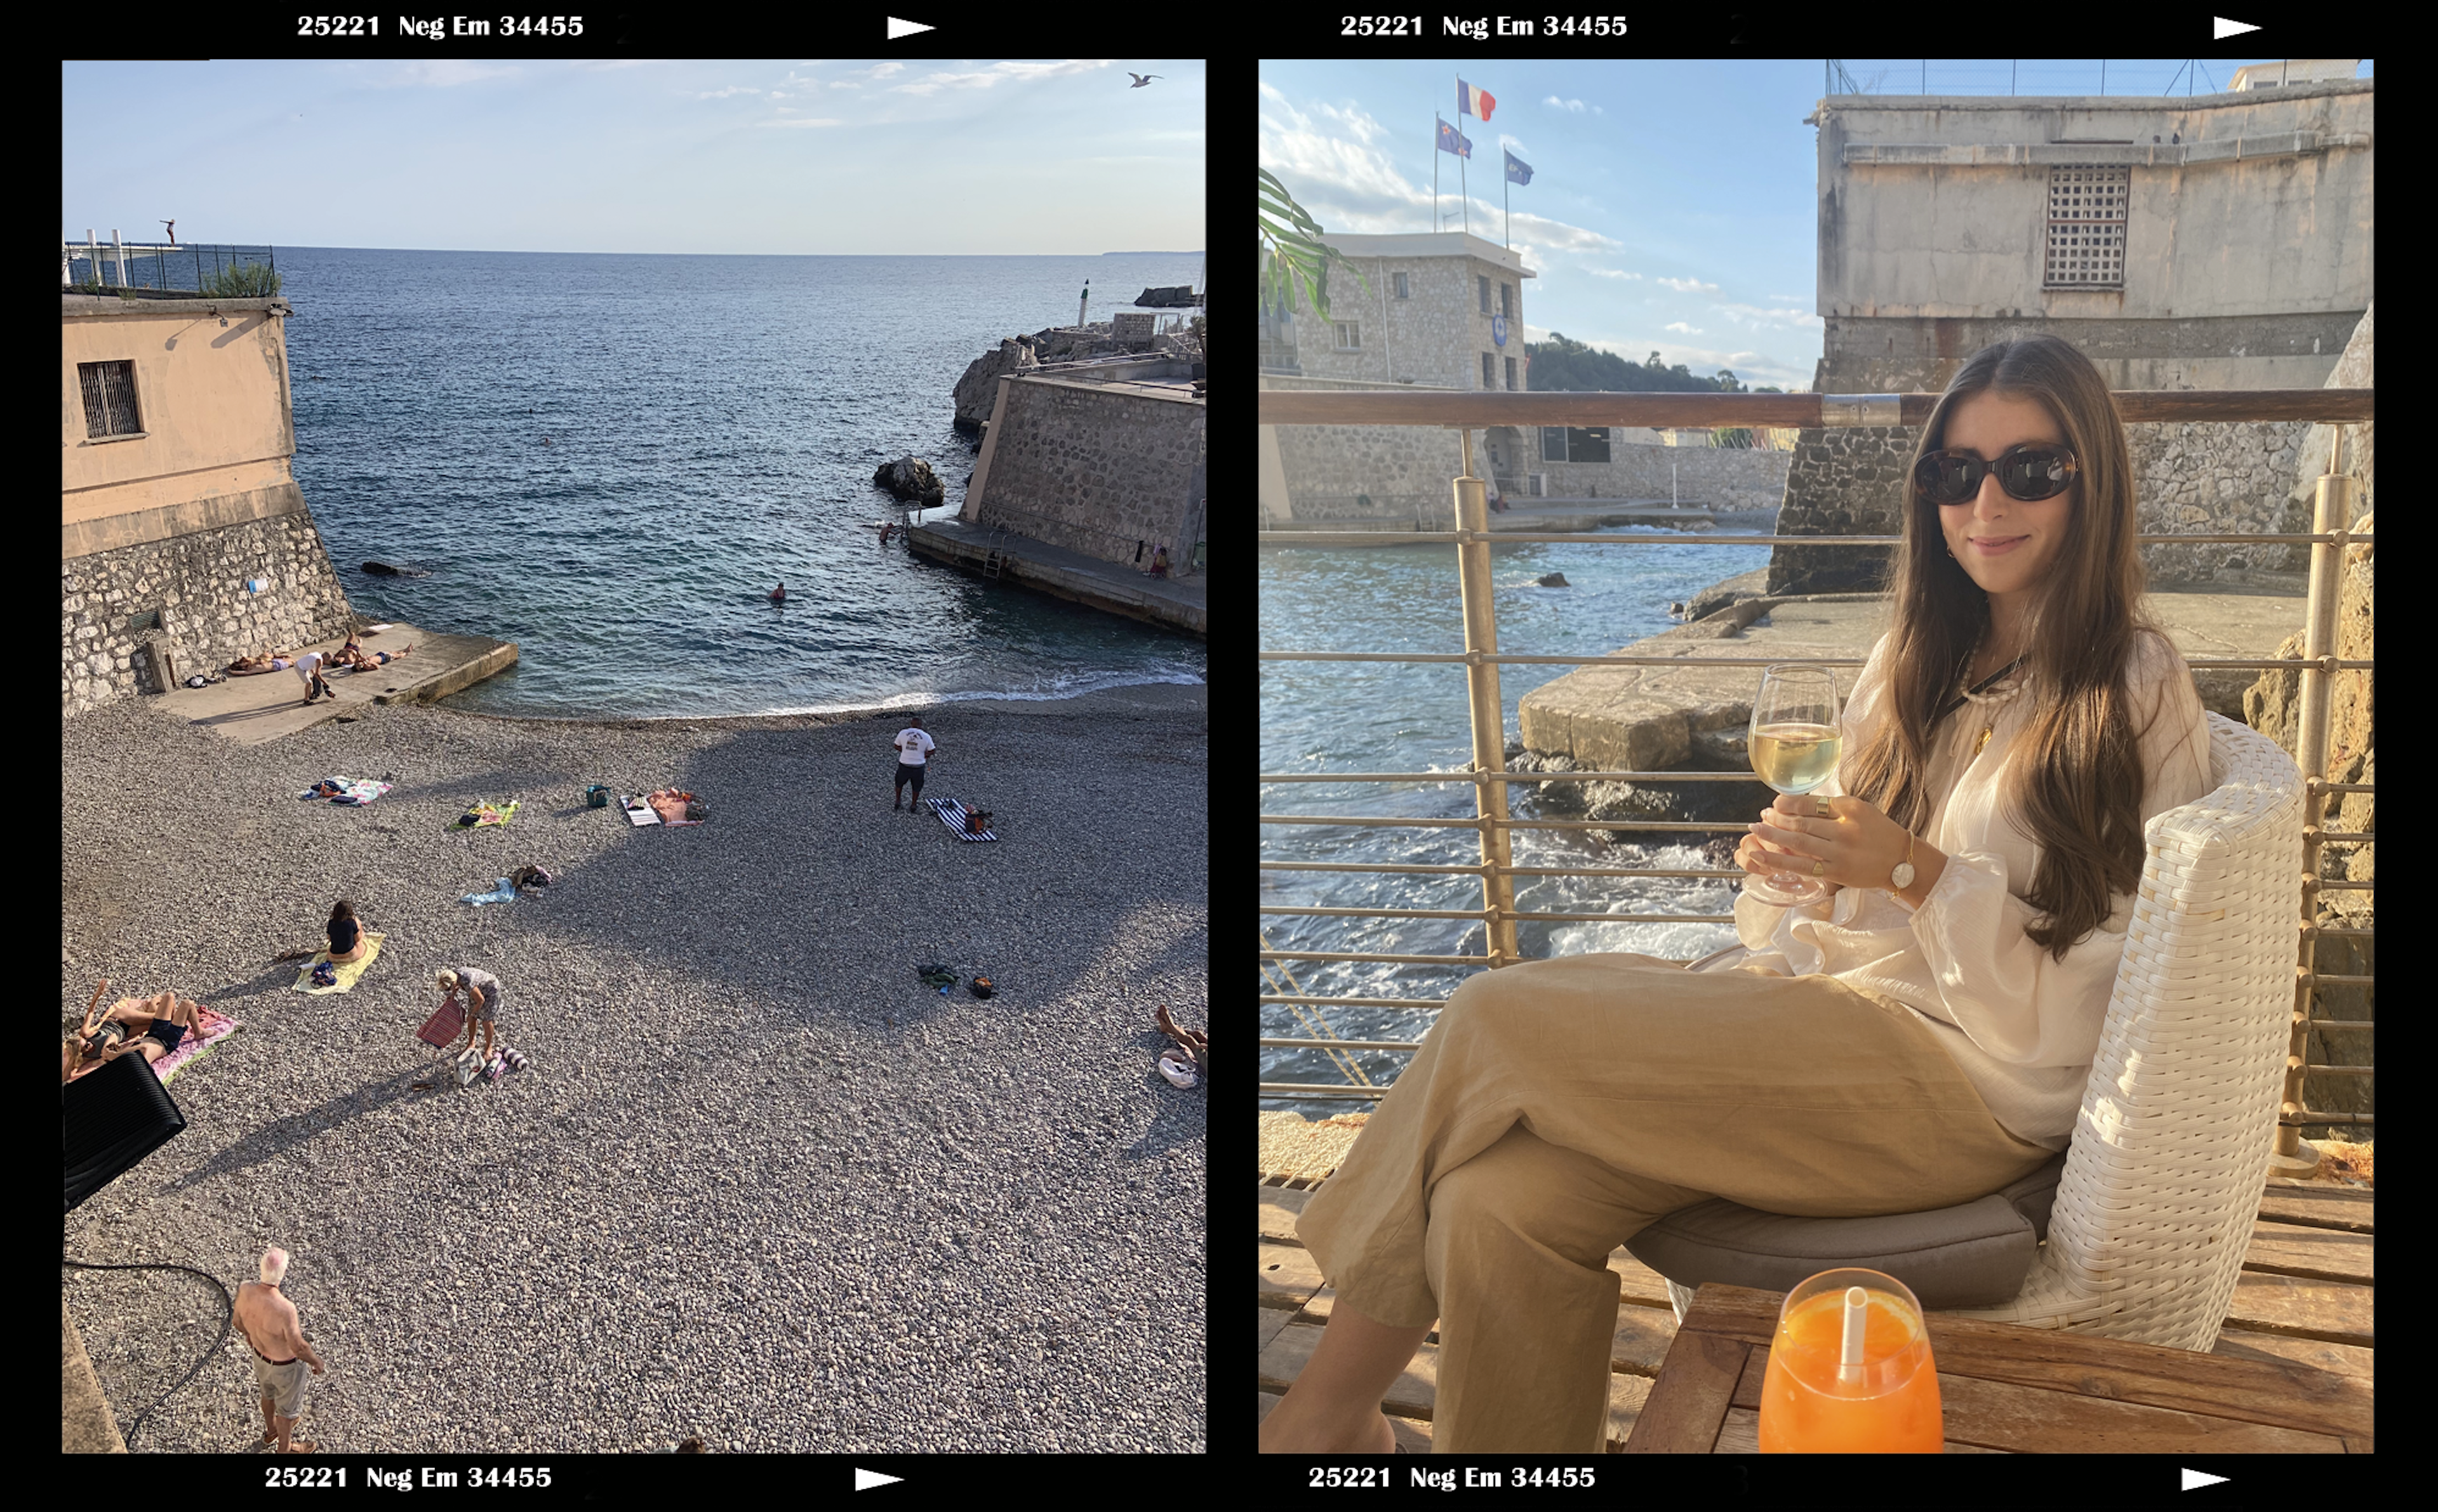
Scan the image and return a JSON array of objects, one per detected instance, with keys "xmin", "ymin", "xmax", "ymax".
[{"xmin": 1260, "ymin": 527, "xmax": 1770, "ymax": 1117}]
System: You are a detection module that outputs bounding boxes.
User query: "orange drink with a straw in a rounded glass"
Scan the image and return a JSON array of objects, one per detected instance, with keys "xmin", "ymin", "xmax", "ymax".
[{"xmin": 1760, "ymin": 1271, "xmax": 1945, "ymax": 1454}]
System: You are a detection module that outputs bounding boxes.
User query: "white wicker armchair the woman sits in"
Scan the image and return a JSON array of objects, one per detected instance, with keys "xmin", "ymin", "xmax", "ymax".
[{"xmin": 1668, "ymin": 715, "xmax": 2301, "ymax": 1351}]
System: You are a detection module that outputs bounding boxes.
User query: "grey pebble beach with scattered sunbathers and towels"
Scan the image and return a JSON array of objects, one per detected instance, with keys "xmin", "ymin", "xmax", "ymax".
[{"xmin": 61, "ymin": 686, "xmax": 1209, "ymax": 1454}]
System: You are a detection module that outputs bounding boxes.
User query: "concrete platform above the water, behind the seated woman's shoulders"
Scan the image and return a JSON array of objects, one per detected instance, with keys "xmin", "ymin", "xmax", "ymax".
[{"xmin": 1502, "ymin": 585, "xmax": 2307, "ymax": 771}]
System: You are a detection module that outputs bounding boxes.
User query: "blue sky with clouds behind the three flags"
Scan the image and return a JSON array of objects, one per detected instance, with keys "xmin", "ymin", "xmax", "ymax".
[{"xmin": 1260, "ymin": 58, "xmax": 2369, "ymax": 390}]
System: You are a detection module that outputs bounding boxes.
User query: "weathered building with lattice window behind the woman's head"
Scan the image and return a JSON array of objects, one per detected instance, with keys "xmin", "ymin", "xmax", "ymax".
[{"xmin": 1770, "ymin": 58, "xmax": 2372, "ymax": 593}]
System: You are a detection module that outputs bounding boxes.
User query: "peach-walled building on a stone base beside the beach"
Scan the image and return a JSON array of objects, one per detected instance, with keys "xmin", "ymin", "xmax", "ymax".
[{"xmin": 58, "ymin": 293, "xmax": 351, "ymax": 715}]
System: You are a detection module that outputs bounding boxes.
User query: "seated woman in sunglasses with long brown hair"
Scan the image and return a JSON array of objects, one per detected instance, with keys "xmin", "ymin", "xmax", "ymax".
[{"xmin": 1260, "ymin": 336, "xmax": 2209, "ymax": 1454}]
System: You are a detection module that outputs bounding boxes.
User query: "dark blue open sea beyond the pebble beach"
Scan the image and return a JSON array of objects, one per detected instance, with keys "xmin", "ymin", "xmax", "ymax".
[{"xmin": 276, "ymin": 246, "xmax": 1207, "ymax": 717}]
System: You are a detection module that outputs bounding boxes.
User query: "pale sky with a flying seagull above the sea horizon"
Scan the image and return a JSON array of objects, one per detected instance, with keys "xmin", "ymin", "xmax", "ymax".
[{"xmin": 61, "ymin": 58, "xmax": 1204, "ymax": 256}]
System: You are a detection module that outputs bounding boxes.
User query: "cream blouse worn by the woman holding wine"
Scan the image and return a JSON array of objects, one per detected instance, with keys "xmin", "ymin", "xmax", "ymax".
[{"xmin": 1736, "ymin": 634, "xmax": 2209, "ymax": 1151}]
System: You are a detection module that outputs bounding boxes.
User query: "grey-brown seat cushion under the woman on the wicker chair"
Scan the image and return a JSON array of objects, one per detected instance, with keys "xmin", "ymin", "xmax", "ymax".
[{"xmin": 1626, "ymin": 1153, "xmax": 2065, "ymax": 1310}]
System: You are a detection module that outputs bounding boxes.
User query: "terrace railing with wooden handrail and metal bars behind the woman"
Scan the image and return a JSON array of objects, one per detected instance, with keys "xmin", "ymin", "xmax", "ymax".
[{"xmin": 1256, "ymin": 388, "xmax": 2375, "ymax": 1161}]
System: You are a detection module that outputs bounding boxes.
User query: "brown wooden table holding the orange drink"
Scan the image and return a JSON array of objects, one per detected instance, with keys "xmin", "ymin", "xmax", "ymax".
[{"xmin": 1626, "ymin": 1285, "xmax": 2372, "ymax": 1454}]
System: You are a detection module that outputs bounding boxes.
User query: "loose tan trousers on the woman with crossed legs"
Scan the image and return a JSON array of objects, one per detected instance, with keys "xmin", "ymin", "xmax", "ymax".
[{"xmin": 1297, "ymin": 956, "xmax": 2055, "ymax": 1454}]
